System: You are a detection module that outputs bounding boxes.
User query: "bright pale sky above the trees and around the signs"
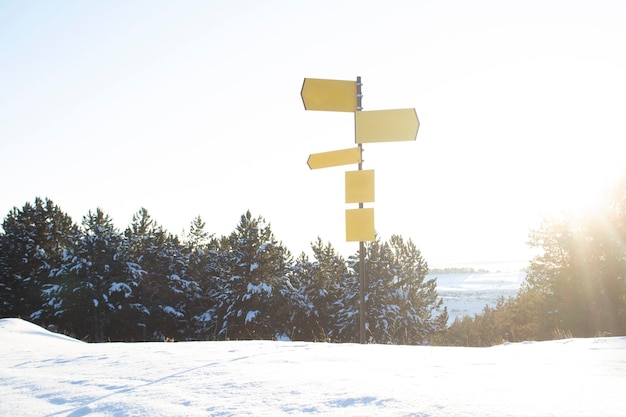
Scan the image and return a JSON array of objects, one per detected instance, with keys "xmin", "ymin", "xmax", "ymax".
[{"xmin": 0, "ymin": 0, "xmax": 626, "ymax": 266}]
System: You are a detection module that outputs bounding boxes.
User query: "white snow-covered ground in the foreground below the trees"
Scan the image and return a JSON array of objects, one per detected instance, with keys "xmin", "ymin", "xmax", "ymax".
[{"xmin": 0, "ymin": 319, "xmax": 626, "ymax": 417}]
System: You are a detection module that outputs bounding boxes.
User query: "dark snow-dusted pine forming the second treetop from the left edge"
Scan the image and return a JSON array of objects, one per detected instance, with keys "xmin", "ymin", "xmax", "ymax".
[{"xmin": 48, "ymin": 208, "xmax": 142, "ymax": 342}]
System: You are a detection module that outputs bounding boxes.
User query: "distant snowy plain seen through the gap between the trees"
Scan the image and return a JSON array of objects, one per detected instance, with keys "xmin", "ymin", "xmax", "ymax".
[{"xmin": 427, "ymin": 271, "xmax": 526, "ymax": 323}]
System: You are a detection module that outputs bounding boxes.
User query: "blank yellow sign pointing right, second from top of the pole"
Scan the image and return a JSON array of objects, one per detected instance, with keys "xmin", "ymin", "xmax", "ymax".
[{"xmin": 354, "ymin": 109, "xmax": 419, "ymax": 143}]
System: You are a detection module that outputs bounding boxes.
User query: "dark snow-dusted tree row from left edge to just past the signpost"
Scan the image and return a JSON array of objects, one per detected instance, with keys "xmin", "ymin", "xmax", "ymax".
[{"xmin": 0, "ymin": 198, "xmax": 448, "ymax": 344}]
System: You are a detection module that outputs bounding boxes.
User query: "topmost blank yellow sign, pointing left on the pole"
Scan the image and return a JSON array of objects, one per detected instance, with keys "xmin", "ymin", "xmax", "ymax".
[{"xmin": 300, "ymin": 78, "xmax": 356, "ymax": 112}]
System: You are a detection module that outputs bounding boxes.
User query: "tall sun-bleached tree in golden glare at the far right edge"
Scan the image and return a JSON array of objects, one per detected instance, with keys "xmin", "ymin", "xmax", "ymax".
[{"xmin": 521, "ymin": 188, "xmax": 626, "ymax": 339}]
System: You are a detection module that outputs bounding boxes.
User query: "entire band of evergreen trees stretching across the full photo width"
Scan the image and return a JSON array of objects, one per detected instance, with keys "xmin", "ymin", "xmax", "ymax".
[{"xmin": 0, "ymin": 175, "xmax": 626, "ymax": 346}]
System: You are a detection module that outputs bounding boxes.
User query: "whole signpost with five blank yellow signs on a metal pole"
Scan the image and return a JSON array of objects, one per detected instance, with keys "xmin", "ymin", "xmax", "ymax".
[{"xmin": 300, "ymin": 77, "xmax": 419, "ymax": 343}]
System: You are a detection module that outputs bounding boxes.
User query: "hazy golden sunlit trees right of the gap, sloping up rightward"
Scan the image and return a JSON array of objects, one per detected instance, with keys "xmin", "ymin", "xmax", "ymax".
[{"xmin": 445, "ymin": 175, "xmax": 626, "ymax": 346}]
